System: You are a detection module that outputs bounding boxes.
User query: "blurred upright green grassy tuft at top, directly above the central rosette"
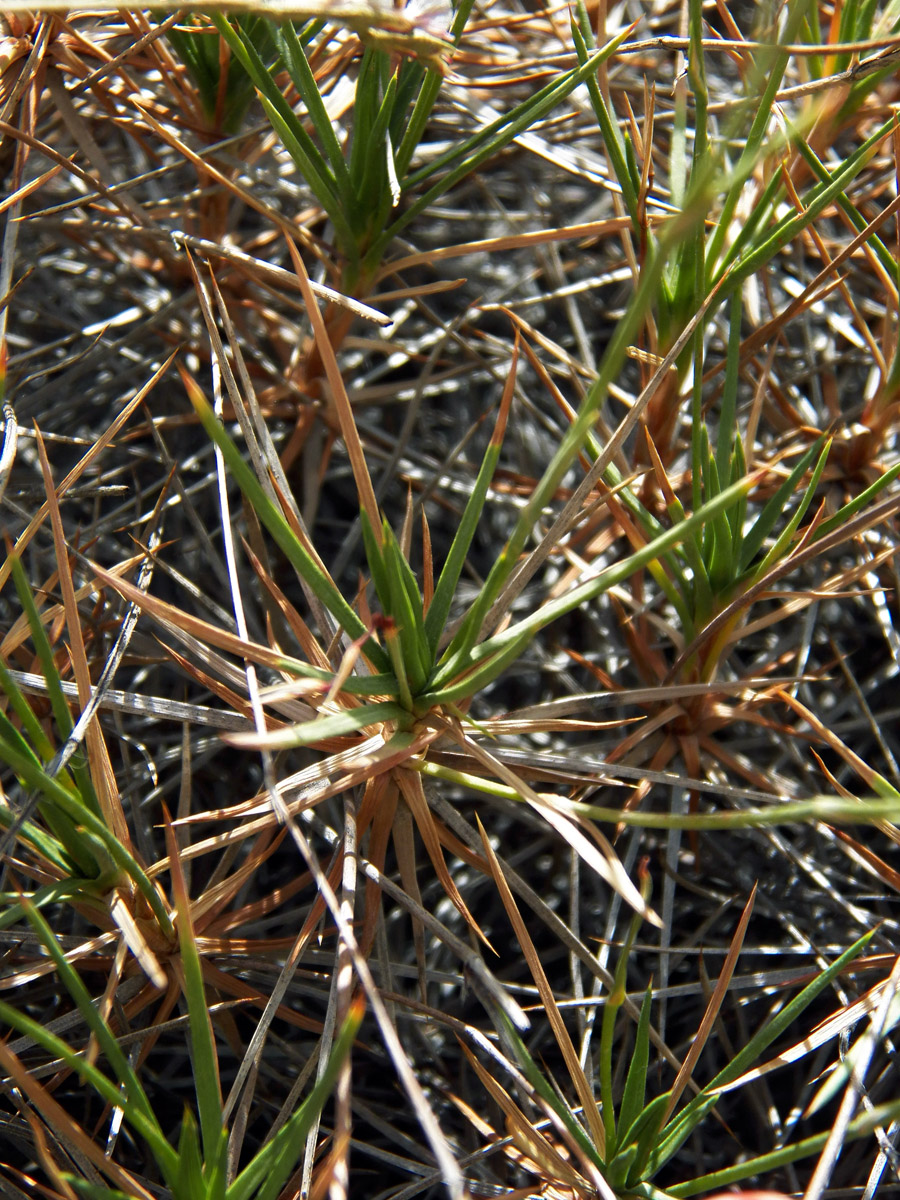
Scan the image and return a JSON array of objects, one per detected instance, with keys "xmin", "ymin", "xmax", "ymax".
[{"xmin": 205, "ymin": 0, "xmax": 629, "ymax": 295}]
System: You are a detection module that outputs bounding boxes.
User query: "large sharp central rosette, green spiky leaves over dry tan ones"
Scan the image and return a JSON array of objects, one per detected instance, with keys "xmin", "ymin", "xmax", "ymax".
[{"xmin": 97, "ymin": 326, "xmax": 748, "ymax": 931}]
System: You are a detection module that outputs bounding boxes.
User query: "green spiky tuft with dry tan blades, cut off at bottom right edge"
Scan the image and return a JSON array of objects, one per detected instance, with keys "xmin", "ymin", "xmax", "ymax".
[{"xmin": 466, "ymin": 849, "xmax": 900, "ymax": 1200}]
